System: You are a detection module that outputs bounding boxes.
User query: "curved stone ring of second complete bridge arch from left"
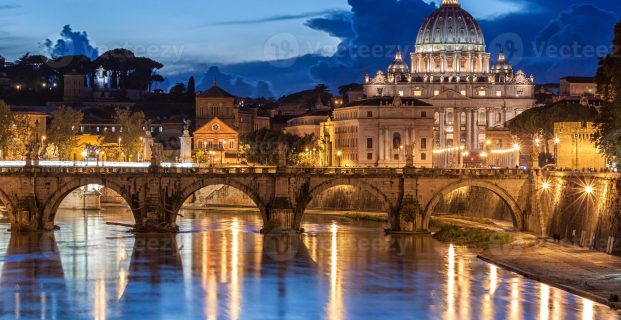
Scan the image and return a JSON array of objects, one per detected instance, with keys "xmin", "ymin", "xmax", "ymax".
[{"xmin": 170, "ymin": 177, "xmax": 267, "ymax": 222}]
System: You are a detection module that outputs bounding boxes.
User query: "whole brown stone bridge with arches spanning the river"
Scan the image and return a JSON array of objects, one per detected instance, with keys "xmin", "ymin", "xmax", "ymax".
[{"xmin": 0, "ymin": 167, "xmax": 542, "ymax": 232}]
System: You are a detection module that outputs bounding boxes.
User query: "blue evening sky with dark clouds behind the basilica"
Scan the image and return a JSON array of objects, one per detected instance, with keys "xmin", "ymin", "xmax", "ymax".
[{"xmin": 0, "ymin": 0, "xmax": 621, "ymax": 96}]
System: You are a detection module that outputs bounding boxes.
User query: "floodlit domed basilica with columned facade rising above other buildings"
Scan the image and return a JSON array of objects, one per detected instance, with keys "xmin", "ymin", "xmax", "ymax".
[{"xmin": 364, "ymin": 0, "xmax": 535, "ymax": 166}]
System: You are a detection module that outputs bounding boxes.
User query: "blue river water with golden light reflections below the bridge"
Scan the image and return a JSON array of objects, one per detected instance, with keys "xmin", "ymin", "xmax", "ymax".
[{"xmin": 0, "ymin": 209, "xmax": 619, "ymax": 320}]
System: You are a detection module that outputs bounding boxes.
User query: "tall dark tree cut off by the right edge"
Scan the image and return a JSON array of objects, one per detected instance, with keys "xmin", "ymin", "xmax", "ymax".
[{"xmin": 595, "ymin": 22, "xmax": 621, "ymax": 159}]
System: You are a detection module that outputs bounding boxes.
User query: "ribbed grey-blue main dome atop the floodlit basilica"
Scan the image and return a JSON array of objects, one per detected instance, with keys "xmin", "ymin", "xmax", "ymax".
[{"xmin": 416, "ymin": 0, "xmax": 485, "ymax": 53}]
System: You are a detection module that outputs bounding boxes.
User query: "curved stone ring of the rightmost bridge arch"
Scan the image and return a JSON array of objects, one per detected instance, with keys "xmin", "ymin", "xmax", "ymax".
[{"xmin": 423, "ymin": 179, "xmax": 524, "ymax": 230}]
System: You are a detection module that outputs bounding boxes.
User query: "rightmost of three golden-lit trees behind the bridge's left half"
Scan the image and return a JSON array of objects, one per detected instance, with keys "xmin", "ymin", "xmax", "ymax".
[{"xmin": 104, "ymin": 108, "xmax": 148, "ymax": 161}]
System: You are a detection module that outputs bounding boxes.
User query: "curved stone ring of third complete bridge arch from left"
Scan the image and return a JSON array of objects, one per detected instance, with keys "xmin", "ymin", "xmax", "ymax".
[{"xmin": 295, "ymin": 177, "xmax": 399, "ymax": 226}]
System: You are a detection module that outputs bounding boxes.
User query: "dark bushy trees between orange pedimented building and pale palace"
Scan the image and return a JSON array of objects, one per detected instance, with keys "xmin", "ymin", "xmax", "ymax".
[{"xmin": 240, "ymin": 129, "xmax": 317, "ymax": 165}]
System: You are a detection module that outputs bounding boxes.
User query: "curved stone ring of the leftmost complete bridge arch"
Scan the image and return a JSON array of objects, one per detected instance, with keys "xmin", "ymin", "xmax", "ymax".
[{"xmin": 43, "ymin": 177, "xmax": 138, "ymax": 229}]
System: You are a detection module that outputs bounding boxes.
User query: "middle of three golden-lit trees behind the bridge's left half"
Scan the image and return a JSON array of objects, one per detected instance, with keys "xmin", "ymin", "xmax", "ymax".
[{"xmin": 47, "ymin": 107, "xmax": 84, "ymax": 160}]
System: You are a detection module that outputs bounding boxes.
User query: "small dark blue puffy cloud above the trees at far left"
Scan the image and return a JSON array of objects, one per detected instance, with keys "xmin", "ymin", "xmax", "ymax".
[{"xmin": 42, "ymin": 25, "xmax": 99, "ymax": 59}]
